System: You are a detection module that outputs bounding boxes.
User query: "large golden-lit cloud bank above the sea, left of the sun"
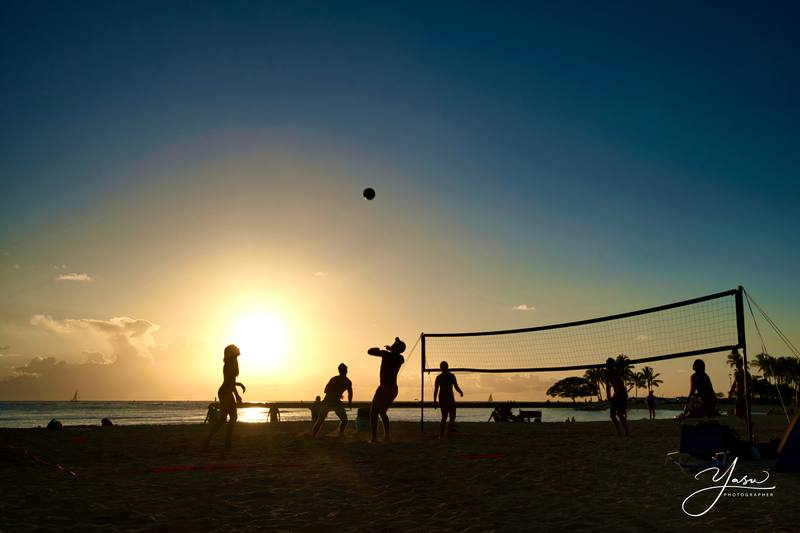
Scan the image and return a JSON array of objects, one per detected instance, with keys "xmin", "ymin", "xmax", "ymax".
[{"xmin": 0, "ymin": 315, "xmax": 212, "ymax": 400}]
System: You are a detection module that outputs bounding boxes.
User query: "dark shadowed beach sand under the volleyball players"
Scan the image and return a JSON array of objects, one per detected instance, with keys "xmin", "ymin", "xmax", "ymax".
[{"xmin": 0, "ymin": 416, "xmax": 800, "ymax": 532}]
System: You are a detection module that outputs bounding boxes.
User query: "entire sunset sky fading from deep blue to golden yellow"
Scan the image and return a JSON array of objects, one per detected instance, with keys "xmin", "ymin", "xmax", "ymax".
[{"xmin": 0, "ymin": 1, "xmax": 800, "ymax": 401}]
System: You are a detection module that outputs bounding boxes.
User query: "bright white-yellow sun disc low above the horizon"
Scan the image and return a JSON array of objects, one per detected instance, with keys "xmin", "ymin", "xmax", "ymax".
[{"xmin": 232, "ymin": 313, "xmax": 288, "ymax": 372}]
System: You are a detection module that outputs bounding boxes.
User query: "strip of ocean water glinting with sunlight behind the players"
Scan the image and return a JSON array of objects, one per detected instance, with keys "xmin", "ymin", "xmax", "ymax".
[{"xmin": 0, "ymin": 401, "xmax": 678, "ymax": 428}]
